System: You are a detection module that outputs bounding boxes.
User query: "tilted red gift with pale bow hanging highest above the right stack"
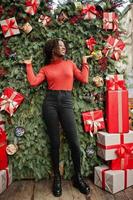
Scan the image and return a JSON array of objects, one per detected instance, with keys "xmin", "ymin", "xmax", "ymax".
[{"xmin": 103, "ymin": 36, "xmax": 125, "ymax": 61}]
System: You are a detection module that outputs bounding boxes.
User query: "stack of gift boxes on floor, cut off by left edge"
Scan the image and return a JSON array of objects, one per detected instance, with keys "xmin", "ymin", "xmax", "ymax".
[{"xmin": 0, "ymin": 114, "xmax": 12, "ymax": 193}]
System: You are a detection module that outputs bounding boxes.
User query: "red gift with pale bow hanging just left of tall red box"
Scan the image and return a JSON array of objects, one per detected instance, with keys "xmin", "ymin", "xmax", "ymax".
[{"xmin": 82, "ymin": 110, "xmax": 105, "ymax": 136}]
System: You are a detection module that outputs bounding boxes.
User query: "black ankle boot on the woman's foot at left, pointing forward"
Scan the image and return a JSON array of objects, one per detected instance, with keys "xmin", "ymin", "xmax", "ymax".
[{"xmin": 53, "ymin": 174, "xmax": 62, "ymax": 197}]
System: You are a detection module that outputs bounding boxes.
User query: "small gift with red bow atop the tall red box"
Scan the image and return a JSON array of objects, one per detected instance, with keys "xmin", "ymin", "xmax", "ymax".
[{"xmin": 106, "ymin": 74, "xmax": 126, "ymax": 90}]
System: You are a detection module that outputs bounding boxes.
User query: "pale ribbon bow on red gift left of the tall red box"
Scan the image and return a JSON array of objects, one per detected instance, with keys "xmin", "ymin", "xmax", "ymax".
[{"xmin": 85, "ymin": 118, "xmax": 103, "ymax": 137}]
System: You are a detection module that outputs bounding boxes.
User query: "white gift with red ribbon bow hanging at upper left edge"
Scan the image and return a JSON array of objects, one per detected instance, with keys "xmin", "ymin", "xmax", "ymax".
[{"xmin": 0, "ymin": 17, "xmax": 20, "ymax": 37}]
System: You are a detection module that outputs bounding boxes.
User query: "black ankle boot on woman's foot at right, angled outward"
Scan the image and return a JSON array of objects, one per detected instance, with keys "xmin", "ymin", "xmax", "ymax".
[{"xmin": 73, "ymin": 174, "xmax": 90, "ymax": 195}]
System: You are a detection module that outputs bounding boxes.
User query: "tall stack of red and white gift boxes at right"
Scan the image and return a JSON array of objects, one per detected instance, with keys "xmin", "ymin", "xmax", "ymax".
[{"xmin": 94, "ymin": 75, "xmax": 133, "ymax": 193}]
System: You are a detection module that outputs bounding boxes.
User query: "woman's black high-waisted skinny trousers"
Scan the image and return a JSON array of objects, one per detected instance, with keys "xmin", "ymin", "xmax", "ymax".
[{"xmin": 43, "ymin": 90, "xmax": 80, "ymax": 173}]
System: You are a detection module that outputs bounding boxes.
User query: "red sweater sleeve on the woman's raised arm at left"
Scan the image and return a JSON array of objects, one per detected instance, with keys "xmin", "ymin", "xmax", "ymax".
[{"xmin": 26, "ymin": 64, "xmax": 45, "ymax": 86}]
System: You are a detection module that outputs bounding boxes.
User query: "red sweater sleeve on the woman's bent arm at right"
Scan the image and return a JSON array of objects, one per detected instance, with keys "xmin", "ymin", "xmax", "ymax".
[{"xmin": 73, "ymin": 63, "xmax": 89, "ymax": 83}]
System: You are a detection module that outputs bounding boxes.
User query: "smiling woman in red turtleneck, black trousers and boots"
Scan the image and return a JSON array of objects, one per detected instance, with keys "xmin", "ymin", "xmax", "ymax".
[{"xmin": 24, "ymin": 39, "xmax": 90, "ymax": 197}]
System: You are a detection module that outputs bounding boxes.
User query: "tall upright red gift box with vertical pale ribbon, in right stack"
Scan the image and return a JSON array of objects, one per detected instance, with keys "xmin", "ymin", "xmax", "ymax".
[{"xmin": 106, "ymin": 90, "xmax": 129, "ymax": 133}]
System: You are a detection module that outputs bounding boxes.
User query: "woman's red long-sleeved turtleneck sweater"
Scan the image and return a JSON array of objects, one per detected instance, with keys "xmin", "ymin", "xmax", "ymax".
[{"xmin": 26, "ymin": 60, "xmax": 89, "ymax": 91}]
